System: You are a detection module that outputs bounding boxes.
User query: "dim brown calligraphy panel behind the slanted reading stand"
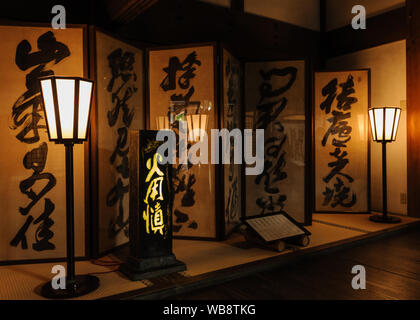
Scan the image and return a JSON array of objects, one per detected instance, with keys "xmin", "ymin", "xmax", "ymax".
[{"xmin": 245, "ymin": 61, "xmax": 308, "ymax": 223}]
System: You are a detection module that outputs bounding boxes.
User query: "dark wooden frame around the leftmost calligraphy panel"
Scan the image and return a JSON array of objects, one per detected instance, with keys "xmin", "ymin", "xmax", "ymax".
[{"xmin": 0, "ymin": 19, "xmax": 93, "ymax": 266}]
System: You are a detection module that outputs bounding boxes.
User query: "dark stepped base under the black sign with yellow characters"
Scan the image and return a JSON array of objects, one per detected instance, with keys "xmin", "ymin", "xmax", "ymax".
[{"xmin": 119, "ymin": 254, "xmax": 187, "ymax": 281}]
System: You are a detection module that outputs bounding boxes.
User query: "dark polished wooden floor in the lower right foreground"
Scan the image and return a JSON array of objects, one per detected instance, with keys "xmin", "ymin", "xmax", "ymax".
[{"xmin": 170, "ymin": 229, "xmax": 420, "ymax": 300}]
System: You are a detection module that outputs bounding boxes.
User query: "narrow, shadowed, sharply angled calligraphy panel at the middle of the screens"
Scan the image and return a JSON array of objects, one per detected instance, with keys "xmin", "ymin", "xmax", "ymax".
[{"xmin": 222, "ymin": 49, "xmax": 243, "ymax": 235}]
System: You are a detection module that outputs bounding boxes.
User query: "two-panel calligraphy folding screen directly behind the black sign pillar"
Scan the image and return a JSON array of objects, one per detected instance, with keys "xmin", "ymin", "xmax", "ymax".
[{"xmin": 147, "ymin": 43, "xmax": 241, "ymax": 239}]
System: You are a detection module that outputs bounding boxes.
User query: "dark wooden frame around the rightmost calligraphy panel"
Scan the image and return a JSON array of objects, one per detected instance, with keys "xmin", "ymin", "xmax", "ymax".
[{"xmin": 311, "ymin": 68, "xmax": 372, "ymax": 214}]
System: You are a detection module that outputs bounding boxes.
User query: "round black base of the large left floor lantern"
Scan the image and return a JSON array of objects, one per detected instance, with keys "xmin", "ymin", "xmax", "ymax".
[{"xmin": 41, "ymin": 275, "xmax": 99, "ymax": 299}]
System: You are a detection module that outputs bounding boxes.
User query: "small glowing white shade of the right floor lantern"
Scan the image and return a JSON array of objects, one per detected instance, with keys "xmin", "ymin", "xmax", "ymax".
[{"xmin": 369, "ymin": 107, "xmax": 401, "ymax": 142}]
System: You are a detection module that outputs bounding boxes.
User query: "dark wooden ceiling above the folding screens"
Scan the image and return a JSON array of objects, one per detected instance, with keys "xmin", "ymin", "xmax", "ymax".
[{"xmin": 0, "ymin": 0, "xmax": 320, "ymax": 60}]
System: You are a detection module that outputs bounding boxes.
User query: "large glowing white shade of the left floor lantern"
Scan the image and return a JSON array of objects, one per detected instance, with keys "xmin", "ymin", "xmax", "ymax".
[{"xmin": 39, "ymin": 76, "xmax": 93, "ymax": 143}]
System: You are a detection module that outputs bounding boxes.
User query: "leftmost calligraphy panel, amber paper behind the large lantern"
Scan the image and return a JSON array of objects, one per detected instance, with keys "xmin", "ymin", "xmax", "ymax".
[{"xmin": 0, "ymin": 26, "xmax": 85, "ymax": 261}]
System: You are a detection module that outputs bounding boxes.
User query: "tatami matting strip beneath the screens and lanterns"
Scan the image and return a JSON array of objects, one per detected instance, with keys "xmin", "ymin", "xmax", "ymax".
[{"xmin": 0, "ymin": 213, "xmax": 420, "ymax": 299}]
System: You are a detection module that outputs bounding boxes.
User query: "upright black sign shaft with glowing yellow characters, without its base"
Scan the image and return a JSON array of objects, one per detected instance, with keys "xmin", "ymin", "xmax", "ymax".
[{"xmin": 129, "ymin": 130, "xmax": 172, "ymax": 258}]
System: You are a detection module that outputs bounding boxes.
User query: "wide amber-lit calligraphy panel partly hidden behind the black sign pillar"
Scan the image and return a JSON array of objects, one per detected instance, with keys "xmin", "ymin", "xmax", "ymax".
[{"xmin": 148, "ymin": 45, "xmax": 217, "ymax": 238}]
